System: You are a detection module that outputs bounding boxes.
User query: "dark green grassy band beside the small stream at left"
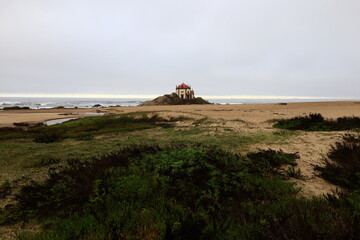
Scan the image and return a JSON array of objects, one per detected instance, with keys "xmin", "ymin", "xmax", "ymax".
[{"xmin": 0, "ymin": 113, "xmax": 181, "ymax": 143}]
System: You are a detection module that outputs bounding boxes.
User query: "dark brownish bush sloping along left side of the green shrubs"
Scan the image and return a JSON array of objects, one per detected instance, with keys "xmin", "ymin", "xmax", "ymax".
[{"xmin": 12, "ymin": 144, "xmax": 158, "ymax": 218}]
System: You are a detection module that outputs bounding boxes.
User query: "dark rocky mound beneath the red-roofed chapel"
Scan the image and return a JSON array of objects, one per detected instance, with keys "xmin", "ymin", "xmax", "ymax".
[{"xmin": 140, "ymin": 93, "xmax": 210, "ymax": 106}]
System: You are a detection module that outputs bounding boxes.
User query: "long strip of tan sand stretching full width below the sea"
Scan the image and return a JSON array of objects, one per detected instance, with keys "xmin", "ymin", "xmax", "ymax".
[{"xmin": 0, "ymin": 101, "xmax": 360, "ymax": 127}]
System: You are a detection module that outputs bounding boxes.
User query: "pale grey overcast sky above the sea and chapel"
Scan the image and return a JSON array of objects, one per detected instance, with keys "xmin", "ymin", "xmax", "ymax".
[{"xmin": 0, "ymin": 0, "xmax": 360, "ymax": 98}]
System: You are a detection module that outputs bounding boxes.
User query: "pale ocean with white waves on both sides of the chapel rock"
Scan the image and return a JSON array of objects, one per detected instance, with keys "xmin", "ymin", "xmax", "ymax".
[{"xmin": 0, "ymin": 97, "xmax": 349, "ymax": 109}]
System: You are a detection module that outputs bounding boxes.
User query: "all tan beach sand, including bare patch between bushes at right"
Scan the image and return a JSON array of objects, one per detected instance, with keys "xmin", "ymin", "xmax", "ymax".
[{"xmin": 0, "ymin": 101, "xmax": 360, "ymax": 197}]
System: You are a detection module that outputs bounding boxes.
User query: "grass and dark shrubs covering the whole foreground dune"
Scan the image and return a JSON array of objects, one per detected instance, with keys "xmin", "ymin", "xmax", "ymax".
[{"xmin": 0, "ymin": 112, "xmax": 360, "ymax": 239}]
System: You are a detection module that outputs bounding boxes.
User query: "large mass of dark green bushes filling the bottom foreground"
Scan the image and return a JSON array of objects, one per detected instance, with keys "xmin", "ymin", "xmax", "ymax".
[{"xmin": 3, "ymin": 146, "xmax": 359, "ymax": 240}]
